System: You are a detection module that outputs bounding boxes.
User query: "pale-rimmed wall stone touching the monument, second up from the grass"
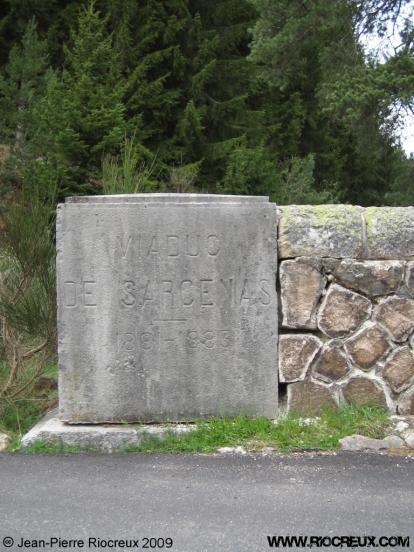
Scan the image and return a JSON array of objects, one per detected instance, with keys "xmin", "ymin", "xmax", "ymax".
[{"xmin": 279, "ymin": 334, "xmax": 322, "ymax": 382}]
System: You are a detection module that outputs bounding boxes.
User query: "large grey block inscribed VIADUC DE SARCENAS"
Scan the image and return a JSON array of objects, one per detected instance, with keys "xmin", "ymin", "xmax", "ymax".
[{"xmin": 57, "ymin": 194, "xmax": 277, "ymax": 423}]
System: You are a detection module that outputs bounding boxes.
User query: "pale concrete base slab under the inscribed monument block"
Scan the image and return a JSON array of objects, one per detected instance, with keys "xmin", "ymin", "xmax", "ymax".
[{"xmin": 22, "ymin": 412, "xmax": 196, "ymax": 452}]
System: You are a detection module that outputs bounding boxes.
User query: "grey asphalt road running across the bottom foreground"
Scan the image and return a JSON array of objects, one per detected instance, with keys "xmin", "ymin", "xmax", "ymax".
[{"xmin": 0, "ymin": 453, "xmax": 414, "ymax": 552}]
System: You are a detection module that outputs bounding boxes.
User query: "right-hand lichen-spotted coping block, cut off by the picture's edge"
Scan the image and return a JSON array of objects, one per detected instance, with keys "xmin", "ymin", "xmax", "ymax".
[{"xmin": 364, "ymin": 207, "xmax": 414, "ymax": 259}]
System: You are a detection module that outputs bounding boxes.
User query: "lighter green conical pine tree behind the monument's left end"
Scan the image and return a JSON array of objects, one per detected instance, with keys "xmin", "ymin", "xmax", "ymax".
[{"xmin": 38, "ymin": 2, "xmax": 126, "ymax": 193}]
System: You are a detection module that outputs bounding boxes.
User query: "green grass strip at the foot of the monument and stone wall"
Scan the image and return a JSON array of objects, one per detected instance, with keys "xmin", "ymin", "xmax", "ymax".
[{"xmin": 125, "ymin": 406, "xmax": 390, "ymax": 453}]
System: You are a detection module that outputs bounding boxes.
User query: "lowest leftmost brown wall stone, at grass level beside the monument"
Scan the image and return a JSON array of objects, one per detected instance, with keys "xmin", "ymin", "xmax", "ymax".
[{"xmin": 287, "ymin": 381, "xmax": 337, "ymax": 416}]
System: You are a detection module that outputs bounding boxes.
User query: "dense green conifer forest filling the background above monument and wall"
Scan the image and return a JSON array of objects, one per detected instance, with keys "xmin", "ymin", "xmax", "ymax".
[{"xmin": 0, "ymin": 0, "xmax": 414, "ymax": 204}]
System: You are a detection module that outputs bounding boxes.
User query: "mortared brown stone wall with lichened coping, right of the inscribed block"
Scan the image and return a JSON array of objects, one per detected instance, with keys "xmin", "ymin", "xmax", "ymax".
[{"xmin": 278, "ymin": 205, "xmax": 414, "ymax": 415}]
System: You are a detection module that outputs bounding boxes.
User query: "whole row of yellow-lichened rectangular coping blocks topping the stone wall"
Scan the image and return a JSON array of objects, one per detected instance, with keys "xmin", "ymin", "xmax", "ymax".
[{"xmin": 278, "ymin": 204, "xmax": 414, "ymax": 259}]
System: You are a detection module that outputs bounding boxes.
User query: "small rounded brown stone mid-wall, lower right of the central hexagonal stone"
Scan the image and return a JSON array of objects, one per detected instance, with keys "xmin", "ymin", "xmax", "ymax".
[{"xmin": 345, "ymin": 324, "xmax": 390, "ymax": 370}]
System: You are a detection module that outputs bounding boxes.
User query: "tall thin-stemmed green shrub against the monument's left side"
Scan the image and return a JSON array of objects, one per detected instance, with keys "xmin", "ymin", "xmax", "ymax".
[{"xmin": 0, "ymin": 161, "xmax": 56, "ymax": 342}]
